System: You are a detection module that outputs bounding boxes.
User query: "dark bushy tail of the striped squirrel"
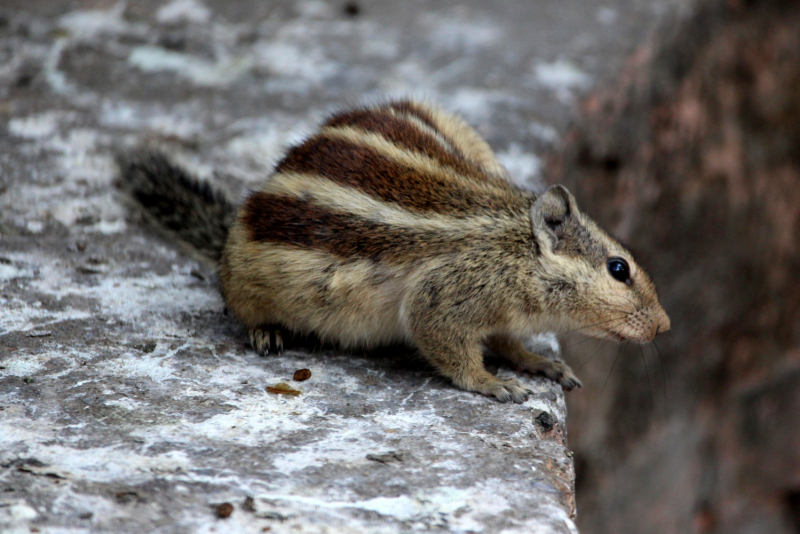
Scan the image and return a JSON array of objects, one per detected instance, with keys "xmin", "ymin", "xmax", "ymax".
[{"xmin": 117, "ymin": 152, "xmax": 235, "ymax": 262}]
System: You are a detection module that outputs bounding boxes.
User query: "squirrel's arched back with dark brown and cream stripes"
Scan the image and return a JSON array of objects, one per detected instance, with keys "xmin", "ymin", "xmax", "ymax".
[{"xmin": 240, "ymin": 101, "xmax": 532, "ymax": 262}]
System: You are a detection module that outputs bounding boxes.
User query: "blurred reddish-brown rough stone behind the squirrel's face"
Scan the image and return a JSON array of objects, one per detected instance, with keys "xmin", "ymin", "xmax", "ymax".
[{"xmin": 553, "ymin": 1, "xmax": 800, "ymax": 533}]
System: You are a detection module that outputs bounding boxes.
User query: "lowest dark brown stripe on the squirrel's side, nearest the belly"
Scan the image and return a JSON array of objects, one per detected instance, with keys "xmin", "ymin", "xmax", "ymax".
[{"xmin": 241, "ymin": 192, "xmax": 464, "ymax": 261}]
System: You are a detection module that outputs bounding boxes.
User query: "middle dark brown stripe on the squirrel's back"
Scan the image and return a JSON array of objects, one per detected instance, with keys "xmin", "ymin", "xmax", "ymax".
[{"xmin": 275, "ymin": 136, "xmax": 524, "ymax": 217}]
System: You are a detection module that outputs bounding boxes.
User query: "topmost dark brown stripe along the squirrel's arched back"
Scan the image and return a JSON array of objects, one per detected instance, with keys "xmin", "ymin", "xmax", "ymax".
[{"xmin": 324, "ymin": 109, "xmax": 478, "ymax": 180}]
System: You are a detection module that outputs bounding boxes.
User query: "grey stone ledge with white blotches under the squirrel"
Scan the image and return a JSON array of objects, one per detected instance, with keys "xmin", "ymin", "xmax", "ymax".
[{"xmin": 0, "ymin": 0, "xmax": 672, "ymax": 533}]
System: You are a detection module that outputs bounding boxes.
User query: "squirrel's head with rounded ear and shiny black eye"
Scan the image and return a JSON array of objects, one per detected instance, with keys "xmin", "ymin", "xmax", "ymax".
[{"xmin": 531, "ymin": 185, "xmax": 670, "ymax": 343}]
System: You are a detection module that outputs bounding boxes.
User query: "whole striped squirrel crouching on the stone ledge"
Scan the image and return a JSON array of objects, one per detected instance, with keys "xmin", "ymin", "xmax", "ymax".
[{"xmin": 119, "ymin": 100, "xmax": 670, "ymax": 403}]
